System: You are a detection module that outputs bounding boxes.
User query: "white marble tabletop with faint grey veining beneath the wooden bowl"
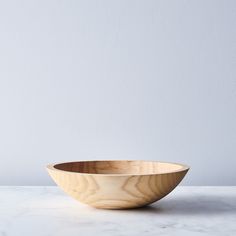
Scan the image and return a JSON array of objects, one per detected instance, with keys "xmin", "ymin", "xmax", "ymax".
[{"xmin": 0, "ymin": 187, "xmax": 236, "ymax": 236}]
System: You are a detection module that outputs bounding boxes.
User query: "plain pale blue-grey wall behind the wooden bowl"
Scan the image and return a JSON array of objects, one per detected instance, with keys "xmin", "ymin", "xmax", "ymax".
[{"xmin": 0, "ymin": 0, "xmax": 236, "ymax": 185}]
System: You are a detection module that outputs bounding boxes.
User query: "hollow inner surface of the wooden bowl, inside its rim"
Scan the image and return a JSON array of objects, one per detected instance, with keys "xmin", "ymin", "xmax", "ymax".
[{"xmin": 53, "ymin": 160, "xmax": 188, "ymax": 175}]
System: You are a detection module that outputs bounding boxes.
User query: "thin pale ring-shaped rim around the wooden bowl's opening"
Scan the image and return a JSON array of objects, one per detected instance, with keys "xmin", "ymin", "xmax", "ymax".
[{"xmin": 46, "ymin": 159, "xmax": 190, "ymax": 177}]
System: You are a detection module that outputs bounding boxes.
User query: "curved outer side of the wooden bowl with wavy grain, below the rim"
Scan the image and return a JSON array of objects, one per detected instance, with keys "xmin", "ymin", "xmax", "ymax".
[{"xmin": 48, "ymin": 168, "xmax": 188, "ymax": 209}]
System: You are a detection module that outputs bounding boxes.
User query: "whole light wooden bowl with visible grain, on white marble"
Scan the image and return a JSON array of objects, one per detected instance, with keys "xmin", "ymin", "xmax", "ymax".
[{"xmin": 47, "ymin": 160, "xmax": 189, "ymax": 209}]
